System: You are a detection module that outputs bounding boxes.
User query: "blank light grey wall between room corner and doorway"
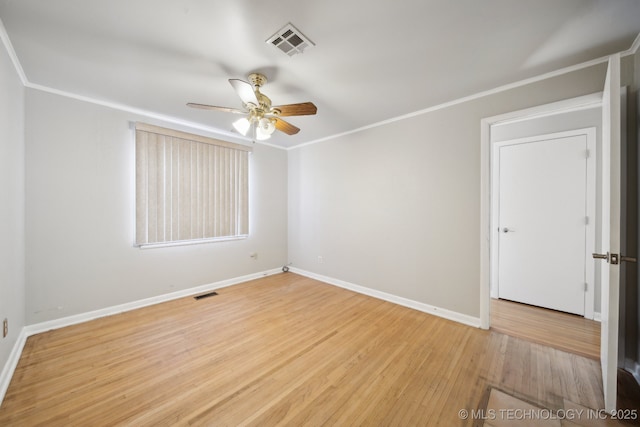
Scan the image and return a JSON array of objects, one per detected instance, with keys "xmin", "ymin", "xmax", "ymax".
[{"xmin": 289, "ymin": 65, "xmax": 605, "ymax": 318}]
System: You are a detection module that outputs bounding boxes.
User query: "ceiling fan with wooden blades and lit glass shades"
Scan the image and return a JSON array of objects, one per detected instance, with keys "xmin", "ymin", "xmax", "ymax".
[{"xmin": 187, "ymin": 73, "xmax": 318, "ymax": 141}]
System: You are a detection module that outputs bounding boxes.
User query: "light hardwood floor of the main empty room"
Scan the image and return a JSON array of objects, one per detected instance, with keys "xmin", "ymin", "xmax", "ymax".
[{"xmin": 0, "ymin": 273, "xmax": 620, "ymax": 426}]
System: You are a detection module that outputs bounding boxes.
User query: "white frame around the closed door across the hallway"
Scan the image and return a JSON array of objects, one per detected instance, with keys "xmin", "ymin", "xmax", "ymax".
[{"xmin": 489, "ymin": 129, "xmax": 596, "ymax": 319}]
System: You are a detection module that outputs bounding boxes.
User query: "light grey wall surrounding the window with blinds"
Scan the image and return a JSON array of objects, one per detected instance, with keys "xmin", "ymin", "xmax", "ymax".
[{"xmin": 25, "ymin": 89, "xmax": 287, "ymax": 324}]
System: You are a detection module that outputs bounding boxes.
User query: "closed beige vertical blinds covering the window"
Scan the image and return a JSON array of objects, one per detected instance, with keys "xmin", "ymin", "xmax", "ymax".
[{"xmin": 136, "ymin": 123, "xmax": 251, "ymax": 246}]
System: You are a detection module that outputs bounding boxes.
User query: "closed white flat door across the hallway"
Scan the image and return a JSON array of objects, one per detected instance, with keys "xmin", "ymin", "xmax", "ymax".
[{"xmin": 496, "ymin": 132, "xmax": 588, "ymax": 315}]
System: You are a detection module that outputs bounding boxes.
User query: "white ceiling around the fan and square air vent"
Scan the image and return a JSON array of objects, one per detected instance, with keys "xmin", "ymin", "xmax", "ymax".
[{"xmin": 0, "ymin": 0, "xmax": 640, "ymax": 147}]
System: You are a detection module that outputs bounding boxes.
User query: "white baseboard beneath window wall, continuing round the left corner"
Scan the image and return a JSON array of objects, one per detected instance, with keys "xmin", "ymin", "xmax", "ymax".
[{"xmin": 0, "ymin": 268, "xmax": 282, "ymax": 404}]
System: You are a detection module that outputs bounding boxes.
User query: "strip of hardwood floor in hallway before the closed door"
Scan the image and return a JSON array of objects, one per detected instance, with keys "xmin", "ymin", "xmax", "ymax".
[{"xmin": 491, "ymin": 299, "xmax": 600, "ymax": 360}]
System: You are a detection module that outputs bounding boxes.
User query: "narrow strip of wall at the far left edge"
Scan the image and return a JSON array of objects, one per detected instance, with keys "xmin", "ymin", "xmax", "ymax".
[{"xmin": 0, "ymin": 34, "xmax": 25, "ymax": 378}]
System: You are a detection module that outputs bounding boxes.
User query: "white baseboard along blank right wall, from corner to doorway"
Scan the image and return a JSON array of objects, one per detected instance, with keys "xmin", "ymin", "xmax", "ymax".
[{"xmin": 290, "ymin": 267, "xmax": 480, "ymax": 328}]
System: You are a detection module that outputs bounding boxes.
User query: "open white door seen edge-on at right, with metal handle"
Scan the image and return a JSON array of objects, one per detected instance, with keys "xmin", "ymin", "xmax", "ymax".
[{"xmin": 600, "ymin": 55, "xmax": 621, "ymax": 411}]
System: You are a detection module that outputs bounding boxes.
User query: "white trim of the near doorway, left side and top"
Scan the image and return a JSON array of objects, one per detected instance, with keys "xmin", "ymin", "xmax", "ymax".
[{"xmin": 480, "ymin": 92, "xmax": 602, "ymax": 329}]
